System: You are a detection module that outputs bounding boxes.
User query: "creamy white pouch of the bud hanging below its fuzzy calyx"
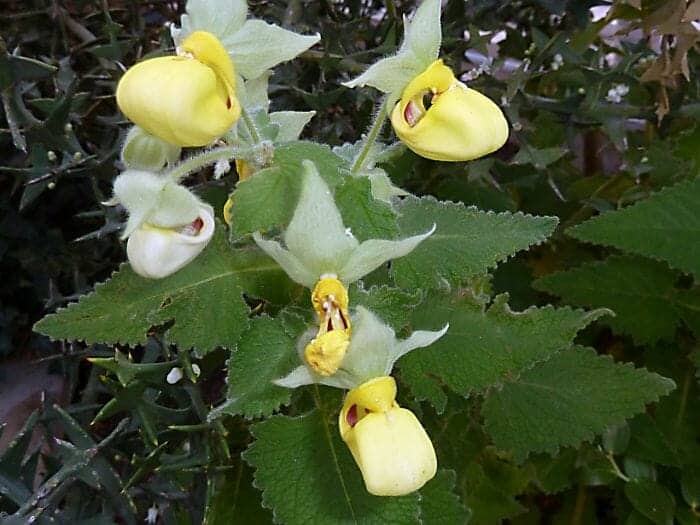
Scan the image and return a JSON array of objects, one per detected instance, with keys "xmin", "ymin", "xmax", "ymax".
[{"xmin": 126, "ymin": 204, "xmax": 214, "ymax": 279}]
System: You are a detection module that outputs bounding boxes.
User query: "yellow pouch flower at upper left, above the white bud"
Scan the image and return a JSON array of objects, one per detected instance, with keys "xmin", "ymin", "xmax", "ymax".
[{"xmin": 117, "ymin": 31, "xmax": 241, "ymax": 147}]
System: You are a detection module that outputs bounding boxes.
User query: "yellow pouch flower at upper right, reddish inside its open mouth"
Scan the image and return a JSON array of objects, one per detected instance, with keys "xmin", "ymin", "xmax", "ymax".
[{"xmin": 391, "ymin": 60, "xmax": 508, "ymax": 162}]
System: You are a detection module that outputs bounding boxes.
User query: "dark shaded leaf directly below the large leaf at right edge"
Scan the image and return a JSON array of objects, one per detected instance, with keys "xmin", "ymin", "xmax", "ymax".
[{"xmin": 533, "ymin": 256, "xmax": 680, "ymax": 343}]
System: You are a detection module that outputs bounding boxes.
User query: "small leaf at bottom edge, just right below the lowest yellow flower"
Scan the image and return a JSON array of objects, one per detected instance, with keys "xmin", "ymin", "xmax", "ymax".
[{"xmin": 420, "ymin": 470, "xmax": 471, "ymax": 525}]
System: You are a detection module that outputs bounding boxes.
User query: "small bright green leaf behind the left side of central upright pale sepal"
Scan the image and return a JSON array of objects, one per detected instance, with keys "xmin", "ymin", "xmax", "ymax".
[{"xmin": 231, "ymin": 142, "xmax": 344, "ymax": 237}]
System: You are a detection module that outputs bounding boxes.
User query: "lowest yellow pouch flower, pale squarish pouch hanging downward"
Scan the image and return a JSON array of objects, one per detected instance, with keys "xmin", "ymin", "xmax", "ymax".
[{"xmin": 339, "ymin": 376, "xmax": 437, "ymax": 496}]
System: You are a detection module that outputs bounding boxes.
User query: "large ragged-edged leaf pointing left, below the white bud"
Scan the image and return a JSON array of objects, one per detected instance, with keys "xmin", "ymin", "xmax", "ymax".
[{"xmin": 34, "ymin": 227, "xmax": 289, "ymax": 354}]
